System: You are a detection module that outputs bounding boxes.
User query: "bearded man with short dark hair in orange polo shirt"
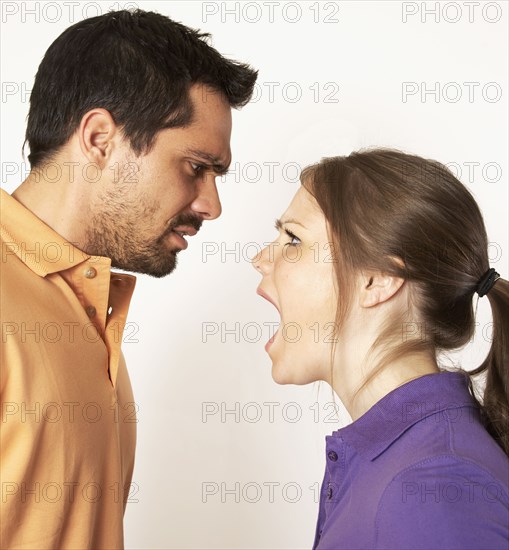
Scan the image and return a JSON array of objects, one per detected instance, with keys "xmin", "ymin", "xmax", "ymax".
[{"xmin": 0, "ymin": 10, "xmax": 257, "ymax": 549}]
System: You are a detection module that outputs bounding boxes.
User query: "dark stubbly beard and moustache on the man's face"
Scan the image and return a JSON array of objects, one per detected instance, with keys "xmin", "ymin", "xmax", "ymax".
[{"xmin": 83, "ymin": 196, "xmax": 202, "ymax": 278}]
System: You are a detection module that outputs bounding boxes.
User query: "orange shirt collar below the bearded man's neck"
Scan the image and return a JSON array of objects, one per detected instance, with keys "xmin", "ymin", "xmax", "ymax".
[{"xmin": 0, "ymin": 188, "xmax": 111, "ymax": 277}]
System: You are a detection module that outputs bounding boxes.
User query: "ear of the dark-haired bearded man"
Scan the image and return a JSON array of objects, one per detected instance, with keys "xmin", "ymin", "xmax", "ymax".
[{"xmin": 78, "ymin": 108, "xmax": 117, "ymax": 168}]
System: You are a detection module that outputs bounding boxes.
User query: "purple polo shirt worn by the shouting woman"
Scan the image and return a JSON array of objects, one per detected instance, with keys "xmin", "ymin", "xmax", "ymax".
[{"xmin": 313, "ymin": 372, "xmax": 509, "ymax": 550}]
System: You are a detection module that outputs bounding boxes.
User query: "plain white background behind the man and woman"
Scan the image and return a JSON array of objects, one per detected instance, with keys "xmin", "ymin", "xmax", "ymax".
[{"xmin": 1, "ymin": 1, "xmax": 509, "ymax": 549}]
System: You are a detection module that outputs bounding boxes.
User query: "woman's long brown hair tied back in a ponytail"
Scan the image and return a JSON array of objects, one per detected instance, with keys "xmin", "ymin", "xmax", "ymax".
[{"xmin": 301, "ymin": 149, "xmax": 509, "ymax": 455}]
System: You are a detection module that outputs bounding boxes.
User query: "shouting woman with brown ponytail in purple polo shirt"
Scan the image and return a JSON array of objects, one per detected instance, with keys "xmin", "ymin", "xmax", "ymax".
[{"xmin": 253, "ymin": 150, "xmax": 509, "ymax": 550}]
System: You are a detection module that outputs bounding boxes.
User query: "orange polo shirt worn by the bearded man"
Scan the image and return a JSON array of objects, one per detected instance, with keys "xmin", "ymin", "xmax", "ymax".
[{"xmin": 0, "ymin": 189, "xmax": 139, "ymax": 550}]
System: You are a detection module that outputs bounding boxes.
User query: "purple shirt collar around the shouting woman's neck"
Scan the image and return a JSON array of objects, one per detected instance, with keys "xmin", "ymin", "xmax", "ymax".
[{"xmin": 328, "ymin": 371, "xmax": 477, "ymax": 460}]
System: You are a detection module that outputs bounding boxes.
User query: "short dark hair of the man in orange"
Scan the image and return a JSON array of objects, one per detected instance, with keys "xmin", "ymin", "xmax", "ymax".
[{"xmin": 25, "ymin": 10, "xmax": 258, "ymax": 168}]
